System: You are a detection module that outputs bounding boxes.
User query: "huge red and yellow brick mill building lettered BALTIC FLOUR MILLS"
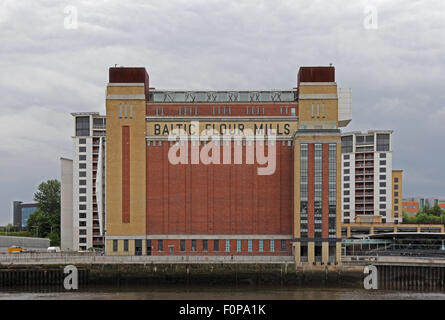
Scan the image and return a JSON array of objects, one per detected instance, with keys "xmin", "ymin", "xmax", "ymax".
[{"xmin": 99, "ymin": 66, "xmax": 351, "ymax": 262}]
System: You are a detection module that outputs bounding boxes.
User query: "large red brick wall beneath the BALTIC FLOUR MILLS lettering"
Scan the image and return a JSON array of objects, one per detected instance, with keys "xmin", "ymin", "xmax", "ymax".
[{"xmin": 146, "ymin": 141, "xmax": 293, "ymax": 235}]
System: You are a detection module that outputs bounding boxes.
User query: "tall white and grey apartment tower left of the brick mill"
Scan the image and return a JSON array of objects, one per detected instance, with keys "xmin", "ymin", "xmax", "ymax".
[{"xmin": 61, "ymin": 112, "xmax": 106, "ymax": 251}]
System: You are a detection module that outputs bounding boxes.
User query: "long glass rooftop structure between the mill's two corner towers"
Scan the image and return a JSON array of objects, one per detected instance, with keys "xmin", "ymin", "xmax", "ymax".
[{"xmin": 149, "ymin": 89, "xmax": 298, "ymax": 103}]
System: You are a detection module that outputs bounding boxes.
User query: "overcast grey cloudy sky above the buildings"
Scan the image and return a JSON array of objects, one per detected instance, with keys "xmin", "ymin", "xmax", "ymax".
[{"xmin": 0, "ymin": 0, "xmax": 445, "ymax": 225}]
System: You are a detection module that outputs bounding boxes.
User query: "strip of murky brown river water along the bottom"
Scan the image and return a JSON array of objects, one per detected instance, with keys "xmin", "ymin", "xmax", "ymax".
[{"xmin": 0, "ymin": 286, "xmax": 445, "ymax": 300}]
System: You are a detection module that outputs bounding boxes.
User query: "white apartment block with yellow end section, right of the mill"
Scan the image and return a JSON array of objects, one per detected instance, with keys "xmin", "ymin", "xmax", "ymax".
[{"xmin": 341, "ymin": 130, "xmax": 402, "ymax": 224}]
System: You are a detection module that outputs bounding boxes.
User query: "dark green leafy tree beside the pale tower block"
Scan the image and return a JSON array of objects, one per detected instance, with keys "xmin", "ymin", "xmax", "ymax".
[{"xmin": 26, "ymin": 180, "xmax": 60, "ymax": 246}]
